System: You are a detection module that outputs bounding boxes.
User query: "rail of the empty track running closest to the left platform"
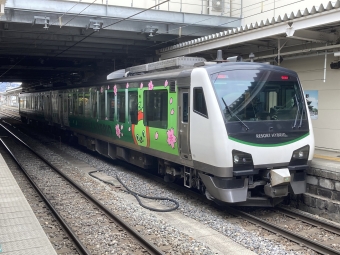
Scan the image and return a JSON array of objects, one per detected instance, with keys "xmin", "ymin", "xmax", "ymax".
[{"xmin": 0, "ymin": 138, "xmax": 91, "ymax": 255}]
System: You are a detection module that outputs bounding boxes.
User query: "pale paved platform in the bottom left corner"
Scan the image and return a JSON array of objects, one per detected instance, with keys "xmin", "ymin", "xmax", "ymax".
[{"xmin": 0, "ymin": 154, "xmax": 57, "ymax": 255}]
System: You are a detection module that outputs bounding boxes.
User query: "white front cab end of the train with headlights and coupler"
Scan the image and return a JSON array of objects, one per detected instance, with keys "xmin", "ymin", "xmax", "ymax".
[{"xmin": 190, "ymin": 63, "xmax": 314, "ymax": 206}]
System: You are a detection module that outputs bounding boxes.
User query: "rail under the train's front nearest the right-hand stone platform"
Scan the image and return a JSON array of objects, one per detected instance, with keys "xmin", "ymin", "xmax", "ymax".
[{"xmin": 273, "ymin": 207, "xmax": 340, "ymax": 236}]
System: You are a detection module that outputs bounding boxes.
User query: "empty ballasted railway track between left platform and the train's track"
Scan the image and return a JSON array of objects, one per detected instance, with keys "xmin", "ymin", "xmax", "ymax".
[{"xmin": 1, "ymin": 125, "xmax": 164, "ymax": 254}]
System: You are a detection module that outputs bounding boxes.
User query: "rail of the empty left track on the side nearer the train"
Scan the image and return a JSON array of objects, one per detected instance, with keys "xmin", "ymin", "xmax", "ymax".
[{"xmin": 0, "ymin": 124, "xmax": 164, "ymax": 255}]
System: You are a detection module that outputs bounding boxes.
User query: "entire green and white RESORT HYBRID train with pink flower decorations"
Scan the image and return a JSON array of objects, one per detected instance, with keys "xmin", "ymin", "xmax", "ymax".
[{"xmin": 20, "ymin": 57, "xmax": 314, "ymax": 206}]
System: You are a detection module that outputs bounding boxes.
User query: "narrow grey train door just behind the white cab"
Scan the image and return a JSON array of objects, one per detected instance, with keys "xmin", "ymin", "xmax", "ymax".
[{"xmin": 178, "ymin": 88, "xmax": 191, "ymax": 160}]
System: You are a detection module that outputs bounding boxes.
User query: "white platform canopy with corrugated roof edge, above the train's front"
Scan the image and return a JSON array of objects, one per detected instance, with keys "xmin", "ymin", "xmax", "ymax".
[{"xmin": 158, "ymin": 0, "xmax": 340, "ymax": 64}]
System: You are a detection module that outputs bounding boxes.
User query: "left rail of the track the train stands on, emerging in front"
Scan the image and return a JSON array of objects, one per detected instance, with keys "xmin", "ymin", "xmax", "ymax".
[{"xmin": 227, "ymin": 207, "xmax": 340, "ymax": 255}]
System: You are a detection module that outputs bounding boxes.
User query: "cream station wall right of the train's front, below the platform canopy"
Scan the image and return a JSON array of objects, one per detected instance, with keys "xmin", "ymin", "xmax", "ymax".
[{"xmin": 282, "ymin": 54, "xmax": 340, "ymax": 151}]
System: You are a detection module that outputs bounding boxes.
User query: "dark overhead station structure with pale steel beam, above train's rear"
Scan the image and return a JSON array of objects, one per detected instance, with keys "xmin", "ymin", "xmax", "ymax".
[{"xmin": 0, "ymin": 0, "xmax": 241, "ymax": 90}]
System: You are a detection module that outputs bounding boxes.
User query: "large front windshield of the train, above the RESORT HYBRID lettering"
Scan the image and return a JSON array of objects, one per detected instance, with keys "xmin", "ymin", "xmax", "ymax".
[{"xmin": 211, "ymin": 69, "xmax": 307, "ymax": 121}]
